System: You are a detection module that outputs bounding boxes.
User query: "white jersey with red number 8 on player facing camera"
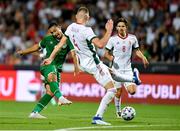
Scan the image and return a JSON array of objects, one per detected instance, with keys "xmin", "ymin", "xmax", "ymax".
[{"xmin": 106, "ymin": 34, "xmax": 139, "ymax": 71}]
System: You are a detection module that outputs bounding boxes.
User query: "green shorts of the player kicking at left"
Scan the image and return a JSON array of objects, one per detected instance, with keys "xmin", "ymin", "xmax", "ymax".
[{"xmin": 40, "ymin": 64, "xmax": 61, "ymax": 84}]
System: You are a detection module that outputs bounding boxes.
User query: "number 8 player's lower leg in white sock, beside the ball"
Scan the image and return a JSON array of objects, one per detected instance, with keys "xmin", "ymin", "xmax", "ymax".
[{"xmin": 114, "ymin": 87, "xmax": 122, "ymax": 118}]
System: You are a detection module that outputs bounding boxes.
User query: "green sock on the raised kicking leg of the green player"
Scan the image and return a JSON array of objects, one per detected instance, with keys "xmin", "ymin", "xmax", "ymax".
[{"xmin": 49, "ymin": 82, "xmax": 62, "ymax": 99}]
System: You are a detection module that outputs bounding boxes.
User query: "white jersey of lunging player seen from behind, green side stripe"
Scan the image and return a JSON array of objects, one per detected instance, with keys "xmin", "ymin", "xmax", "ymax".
[{"xmin": 65, "ymin": 23, "xmax": 100, "ymax": 73}]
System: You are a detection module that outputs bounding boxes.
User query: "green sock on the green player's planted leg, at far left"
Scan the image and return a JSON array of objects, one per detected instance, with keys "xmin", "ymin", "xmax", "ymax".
[{"xmin": 33, "ymin": 94, "xmax": 52, "ymax": 112}]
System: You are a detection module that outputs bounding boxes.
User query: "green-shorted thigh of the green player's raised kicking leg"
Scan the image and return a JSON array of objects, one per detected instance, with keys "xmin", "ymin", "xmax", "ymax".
[{"xmin": 40, "ymin": 65, "xmax": 58, "ymax": 82}]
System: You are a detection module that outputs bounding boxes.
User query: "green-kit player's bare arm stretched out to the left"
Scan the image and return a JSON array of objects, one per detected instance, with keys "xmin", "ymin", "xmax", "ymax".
[{"xmin": 16, "ymin": 44, "xmax": 40, "ymax": 55}]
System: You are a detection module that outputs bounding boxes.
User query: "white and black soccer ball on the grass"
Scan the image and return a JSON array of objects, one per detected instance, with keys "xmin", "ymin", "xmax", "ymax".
[{"xmin": 121, "ymin": 106, "xmax": 136, "ymax": 121}]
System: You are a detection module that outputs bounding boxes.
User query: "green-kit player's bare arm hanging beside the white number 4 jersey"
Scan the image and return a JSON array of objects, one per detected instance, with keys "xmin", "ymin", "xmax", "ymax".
[{"xmin": 71, "ymin": 50, "xmax": 81, "ymax": 76}]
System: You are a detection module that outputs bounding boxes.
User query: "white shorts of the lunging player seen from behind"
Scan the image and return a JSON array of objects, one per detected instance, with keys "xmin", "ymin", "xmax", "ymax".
[{"xmin": 81, "ymin": 63, "xmax": 114, "ymax": 87}]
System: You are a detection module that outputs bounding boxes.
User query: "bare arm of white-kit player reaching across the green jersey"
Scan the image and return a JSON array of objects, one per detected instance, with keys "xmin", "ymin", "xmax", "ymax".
[{"xmin": 43, "ymin": 35, "xmax": 67, "ymax": 65}]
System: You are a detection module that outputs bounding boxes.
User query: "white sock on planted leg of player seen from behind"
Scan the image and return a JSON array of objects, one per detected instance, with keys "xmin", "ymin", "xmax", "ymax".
[{"xmin": 95, "ymin": 88, "xmax": 116, "ymax": 118}]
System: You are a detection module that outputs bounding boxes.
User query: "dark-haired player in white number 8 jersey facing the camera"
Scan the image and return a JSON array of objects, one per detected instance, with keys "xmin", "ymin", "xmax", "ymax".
[{"xmin": 104, "ymin": 18, "xmax": 149, "ymax": 117}]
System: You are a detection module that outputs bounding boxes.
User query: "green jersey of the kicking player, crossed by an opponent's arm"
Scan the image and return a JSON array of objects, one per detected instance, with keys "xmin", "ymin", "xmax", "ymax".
[{"xmin": 39, "ymin": 35, "xmax": 74, "ymax": 71}]
